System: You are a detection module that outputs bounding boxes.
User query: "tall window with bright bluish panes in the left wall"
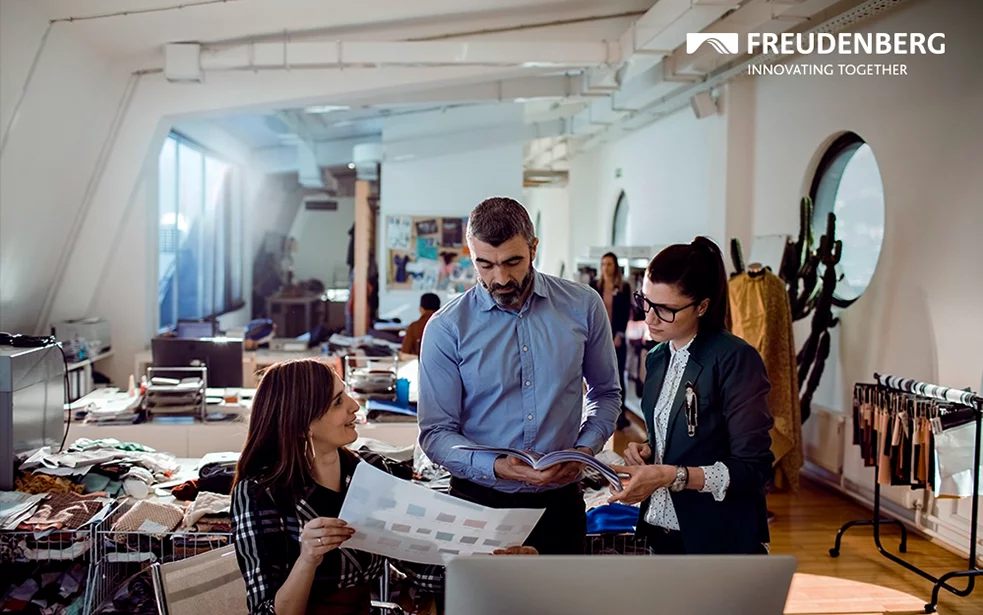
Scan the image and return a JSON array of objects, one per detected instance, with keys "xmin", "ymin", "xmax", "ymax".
[{"xmin": 157, "ymin": 133, "xmax": 243, "ymax": 328}]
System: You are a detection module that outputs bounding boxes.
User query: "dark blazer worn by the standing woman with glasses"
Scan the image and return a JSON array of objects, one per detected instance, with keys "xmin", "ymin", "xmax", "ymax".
[{"xmin": 639, "ymin": 331, "xmax": 775, "ymax": 554}]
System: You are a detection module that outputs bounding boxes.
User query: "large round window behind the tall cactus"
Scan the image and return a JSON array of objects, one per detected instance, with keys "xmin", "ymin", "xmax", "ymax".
[{"xmin": 810, "ymin": 132, "xmax": 884, "ymax": 307}]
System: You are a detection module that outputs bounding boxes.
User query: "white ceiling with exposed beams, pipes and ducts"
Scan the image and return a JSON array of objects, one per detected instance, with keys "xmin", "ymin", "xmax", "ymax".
[{"xmin": 44, "ymin": 0, "xmax": 876, "ymax": 168}]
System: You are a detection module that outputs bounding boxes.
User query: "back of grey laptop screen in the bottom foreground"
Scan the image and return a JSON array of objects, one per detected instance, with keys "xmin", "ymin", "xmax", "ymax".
[{"xmin": 446, "ymin": 555, "xmax": 796, "ymax": 615}]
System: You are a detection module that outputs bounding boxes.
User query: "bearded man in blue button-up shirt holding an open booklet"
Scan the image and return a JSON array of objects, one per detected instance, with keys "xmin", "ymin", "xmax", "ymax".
[{"xmin": 418, "ymin": 198, "xmax": 621, "ymax": 553}]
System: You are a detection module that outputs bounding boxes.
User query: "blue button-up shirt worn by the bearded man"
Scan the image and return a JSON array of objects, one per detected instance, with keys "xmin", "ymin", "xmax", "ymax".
[{"xmin": 419, "ymin": 271, "xmax": 621, "ymax": 492}]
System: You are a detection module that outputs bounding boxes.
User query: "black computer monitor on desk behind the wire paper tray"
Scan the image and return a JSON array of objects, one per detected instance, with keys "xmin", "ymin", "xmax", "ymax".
[{"xmin": 150, "ymin": 337, "xmax": 248, "ymax": 388}]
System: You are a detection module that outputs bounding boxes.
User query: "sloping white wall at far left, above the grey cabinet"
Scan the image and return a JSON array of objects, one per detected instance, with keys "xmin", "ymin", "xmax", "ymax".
[{"xmin": 0, "ymin": 0, "xmax": 129, "ymax": 333}]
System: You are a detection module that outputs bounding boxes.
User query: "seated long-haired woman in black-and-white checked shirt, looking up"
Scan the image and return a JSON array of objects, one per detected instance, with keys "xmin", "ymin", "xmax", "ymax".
[{"xmin": 232, "ymin": 359, "xmax": 526, "ymax": 615}]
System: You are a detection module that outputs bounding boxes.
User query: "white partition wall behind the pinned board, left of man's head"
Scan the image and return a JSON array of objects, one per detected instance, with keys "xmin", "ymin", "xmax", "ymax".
[{"xmin": 376, "ymin": 105, "xmax": 523, "ymax": 321}]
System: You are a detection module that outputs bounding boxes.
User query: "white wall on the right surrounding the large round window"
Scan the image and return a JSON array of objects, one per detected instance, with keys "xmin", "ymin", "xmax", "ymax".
[{"xmin": 754, "ymin": 0, "xmax": 983, "ymax": 540}]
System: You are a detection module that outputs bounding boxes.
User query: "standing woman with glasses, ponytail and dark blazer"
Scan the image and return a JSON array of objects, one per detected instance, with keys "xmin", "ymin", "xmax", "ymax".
[{"xmin": 610, "ymin": 237, "xmax": 774, "ymax": 554}]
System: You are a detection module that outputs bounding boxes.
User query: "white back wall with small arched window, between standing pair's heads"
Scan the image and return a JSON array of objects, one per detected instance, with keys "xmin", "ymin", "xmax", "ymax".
[{"xmin": 567, "ymin": 103, "xmax": 727, "ymax": 271}]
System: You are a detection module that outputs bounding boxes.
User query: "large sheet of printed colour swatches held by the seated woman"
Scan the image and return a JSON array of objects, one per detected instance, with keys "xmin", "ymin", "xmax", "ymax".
[{"xmin": 338, "ymin": 463, "xmax": 543, "ymax": 566}]
